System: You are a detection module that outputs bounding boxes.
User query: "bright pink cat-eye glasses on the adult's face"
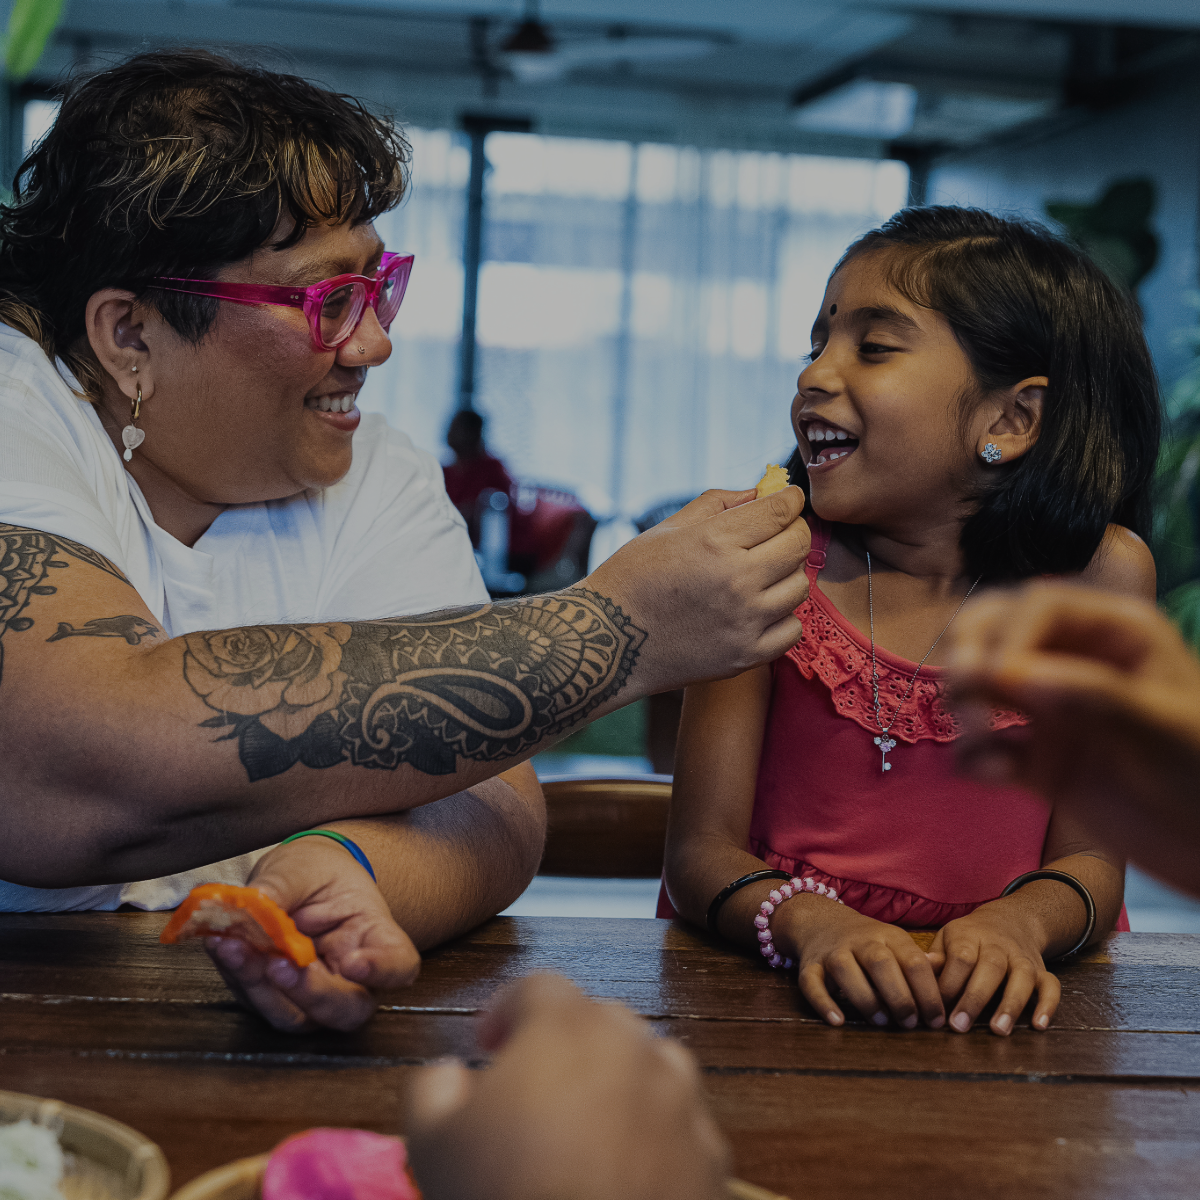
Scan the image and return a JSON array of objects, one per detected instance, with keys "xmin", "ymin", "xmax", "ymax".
[{"xmin": 152, "ymin": 253, "xmax": 414, "ymax": 350}]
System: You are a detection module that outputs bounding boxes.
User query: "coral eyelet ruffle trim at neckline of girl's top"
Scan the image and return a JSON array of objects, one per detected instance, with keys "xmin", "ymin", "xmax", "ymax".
[{"xmin": 786, "ymin": 584, "xmax": 1026, "ymax": 744}]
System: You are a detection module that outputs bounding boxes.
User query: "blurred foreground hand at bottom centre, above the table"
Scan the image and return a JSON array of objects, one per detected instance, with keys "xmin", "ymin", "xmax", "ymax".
[{"xmin": 407, "ymin": 974, "xmax": 728, "ymax": 1200}]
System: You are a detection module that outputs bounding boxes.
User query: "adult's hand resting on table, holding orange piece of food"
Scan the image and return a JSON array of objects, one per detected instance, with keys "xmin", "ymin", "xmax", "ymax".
[{"xmin": 205, "ymin": 838, "xmax": 421, "ymax": 1033}]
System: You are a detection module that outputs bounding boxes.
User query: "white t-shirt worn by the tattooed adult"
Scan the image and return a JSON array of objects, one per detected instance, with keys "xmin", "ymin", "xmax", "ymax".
[{"xmin": 0, "ymin": 324, "xmax": 487, "ymax": 912}]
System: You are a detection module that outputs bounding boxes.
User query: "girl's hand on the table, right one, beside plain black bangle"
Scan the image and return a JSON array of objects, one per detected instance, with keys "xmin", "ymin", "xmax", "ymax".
[{"xmin": 929, "ymin": 898, "xmax": 1062, "ymax": 1037}]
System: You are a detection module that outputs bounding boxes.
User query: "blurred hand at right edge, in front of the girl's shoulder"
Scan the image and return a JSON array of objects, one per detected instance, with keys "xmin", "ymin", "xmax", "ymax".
[{"xmin": 950, "ymin": 582, "xmax": 1200, "ymax": 894}]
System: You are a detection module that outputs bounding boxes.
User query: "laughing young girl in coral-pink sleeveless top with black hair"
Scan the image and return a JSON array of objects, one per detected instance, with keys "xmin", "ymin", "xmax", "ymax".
[{"xmin": 660, "ymin": 208, "xmax": 1158, "ymax": 1034}]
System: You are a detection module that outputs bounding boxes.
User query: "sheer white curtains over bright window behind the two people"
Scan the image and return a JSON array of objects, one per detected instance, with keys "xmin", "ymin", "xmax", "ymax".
[{"xmin": 364, "ymin": 130, "xmax": 907, "ymax": 516}]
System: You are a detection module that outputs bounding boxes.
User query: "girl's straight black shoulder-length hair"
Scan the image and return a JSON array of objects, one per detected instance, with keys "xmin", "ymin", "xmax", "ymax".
[{"xmin": 834, "ymin": 208, "xmax": 1160, "ymax": 580}]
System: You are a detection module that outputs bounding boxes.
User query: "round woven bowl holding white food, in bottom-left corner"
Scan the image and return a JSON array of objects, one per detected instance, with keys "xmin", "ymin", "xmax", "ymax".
[{"xmin": 0, "ymin": 1092, "xmax": 170, "ymax": 1200}]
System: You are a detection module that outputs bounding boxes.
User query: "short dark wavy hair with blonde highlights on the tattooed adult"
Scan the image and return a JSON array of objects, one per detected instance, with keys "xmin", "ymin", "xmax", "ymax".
[{"xmin": 0, "ymin": 50, "xmax": 409, "ymax": 400}]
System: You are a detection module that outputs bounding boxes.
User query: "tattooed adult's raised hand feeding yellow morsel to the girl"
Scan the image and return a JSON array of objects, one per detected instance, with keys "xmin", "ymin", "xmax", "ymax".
[{"xmin": 582, "ymin": 487, "xmax": 810, "ymax": 692}]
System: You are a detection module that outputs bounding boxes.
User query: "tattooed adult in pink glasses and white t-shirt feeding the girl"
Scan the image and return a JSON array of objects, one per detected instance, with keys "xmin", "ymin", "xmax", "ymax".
[{"xmin": 0, "ymin": 52, "xmax": 808, "ymax": 1028}]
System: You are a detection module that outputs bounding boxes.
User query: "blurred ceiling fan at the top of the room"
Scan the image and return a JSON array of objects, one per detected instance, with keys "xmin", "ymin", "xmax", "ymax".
[{"xmin": 497, "ymin": 0, "xmax": 715, "ymax": 83}]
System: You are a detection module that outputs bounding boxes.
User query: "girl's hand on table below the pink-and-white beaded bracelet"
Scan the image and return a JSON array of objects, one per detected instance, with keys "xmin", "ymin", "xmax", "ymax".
[{"xmin": 787, "ymin": 895, "xmax": 946, "ymax": 1030}]
